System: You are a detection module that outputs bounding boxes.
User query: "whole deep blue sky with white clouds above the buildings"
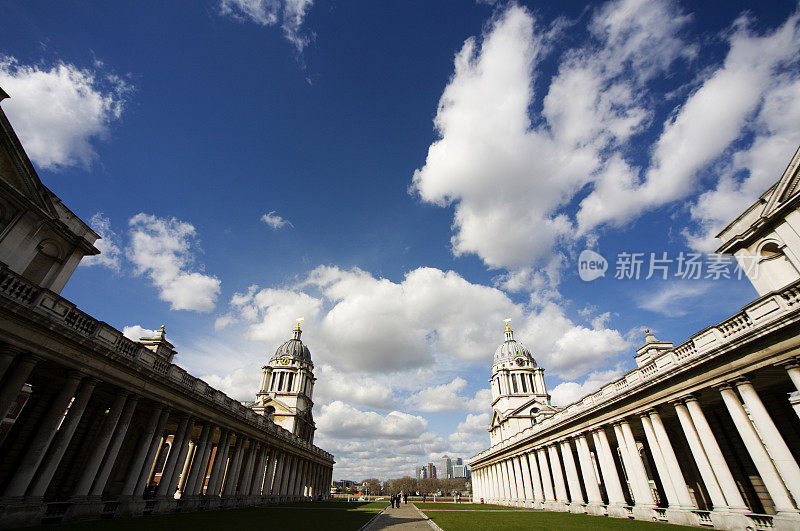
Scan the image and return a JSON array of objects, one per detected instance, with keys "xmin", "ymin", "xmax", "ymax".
[{"xmin": 0, "ymin": 0, "xmax": 800, "ymax": 479}]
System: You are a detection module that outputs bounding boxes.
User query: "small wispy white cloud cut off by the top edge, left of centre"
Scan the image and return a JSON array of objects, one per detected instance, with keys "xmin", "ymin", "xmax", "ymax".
[{"xmin": 220, "ymin": 0, "xmax": 314, "ymax": 52}]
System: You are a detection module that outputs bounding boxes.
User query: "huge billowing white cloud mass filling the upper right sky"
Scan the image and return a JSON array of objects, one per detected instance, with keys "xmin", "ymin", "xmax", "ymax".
[{"xmin": 411, "ymin": 0, "xmax": 800, "ymax": 270}]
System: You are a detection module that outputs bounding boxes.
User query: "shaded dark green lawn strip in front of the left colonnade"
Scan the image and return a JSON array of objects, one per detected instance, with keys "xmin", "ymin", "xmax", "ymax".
[{"xmin": 29, "ymin": 502, "xmax": 387, "ymax": 531}]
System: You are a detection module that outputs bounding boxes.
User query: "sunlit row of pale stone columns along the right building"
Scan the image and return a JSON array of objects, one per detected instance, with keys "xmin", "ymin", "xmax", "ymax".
[{"xmin": 472, "ymin": 360, "xmax": 800, "ymax": 529}]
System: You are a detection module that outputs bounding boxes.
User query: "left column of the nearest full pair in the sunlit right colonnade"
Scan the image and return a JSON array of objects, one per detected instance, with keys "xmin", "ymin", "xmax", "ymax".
[{"xmin": 718, "ymin": 384, "xmax": 795, "ymax": 513}]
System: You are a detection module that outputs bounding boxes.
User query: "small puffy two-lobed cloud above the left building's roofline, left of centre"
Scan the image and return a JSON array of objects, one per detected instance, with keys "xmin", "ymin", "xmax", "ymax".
[{"xmin": 127, "ymin": 213, "xmax": 220, "ymax": 312}]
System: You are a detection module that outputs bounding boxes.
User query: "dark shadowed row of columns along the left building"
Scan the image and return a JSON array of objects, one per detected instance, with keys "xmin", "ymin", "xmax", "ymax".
[{"xmin": 0, "ymin": 345, "xmax": 333, "ymax": 524}]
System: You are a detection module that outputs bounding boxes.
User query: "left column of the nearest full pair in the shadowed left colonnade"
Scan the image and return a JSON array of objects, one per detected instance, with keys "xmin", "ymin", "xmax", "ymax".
[{"xmin": 3, "ymin": 371, "xmax": 82, "ymax": 497}]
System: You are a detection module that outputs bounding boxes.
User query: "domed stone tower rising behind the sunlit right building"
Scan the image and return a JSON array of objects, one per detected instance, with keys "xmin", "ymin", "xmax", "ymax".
[{"xmin": 489, "ymin": 320, "xmax": 555, "ymax": 444}]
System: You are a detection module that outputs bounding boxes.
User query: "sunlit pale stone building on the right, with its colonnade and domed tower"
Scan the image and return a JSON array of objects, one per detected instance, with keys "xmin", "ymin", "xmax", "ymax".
[{"xmin": 470, "ymin": 143, "xmax": 800, "ymax": 530}]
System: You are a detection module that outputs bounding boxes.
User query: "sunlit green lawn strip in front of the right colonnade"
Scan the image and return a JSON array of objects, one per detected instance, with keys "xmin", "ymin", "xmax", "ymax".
[{"xmin": 420, "ymin": 510, "xmax": 694, "ymax": 531}]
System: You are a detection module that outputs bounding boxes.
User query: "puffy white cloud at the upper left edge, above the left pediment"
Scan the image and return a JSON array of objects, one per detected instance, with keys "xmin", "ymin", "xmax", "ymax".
[{"xmin": 0, "ymin": 55, "xmax": 132, "ymax": 170}]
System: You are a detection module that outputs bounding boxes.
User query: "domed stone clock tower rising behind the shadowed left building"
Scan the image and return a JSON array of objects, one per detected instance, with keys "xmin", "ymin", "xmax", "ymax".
[{"xmin": 252, "ymin": 320, "xmax": 316, "ymax": 443}]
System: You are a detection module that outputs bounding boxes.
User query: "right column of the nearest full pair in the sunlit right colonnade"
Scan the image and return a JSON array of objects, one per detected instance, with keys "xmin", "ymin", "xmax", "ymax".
[{"xmin": 734, "ymin": 378, "xmax": 800, "ymax": 503}]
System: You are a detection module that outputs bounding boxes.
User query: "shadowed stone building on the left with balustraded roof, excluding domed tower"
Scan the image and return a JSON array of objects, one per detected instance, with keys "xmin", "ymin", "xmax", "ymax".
[{"xmin": 0, "ymin": 90, "xmax": 334, "ymax": 527}]
